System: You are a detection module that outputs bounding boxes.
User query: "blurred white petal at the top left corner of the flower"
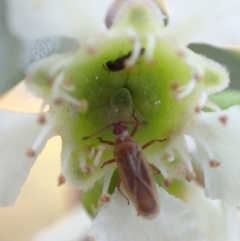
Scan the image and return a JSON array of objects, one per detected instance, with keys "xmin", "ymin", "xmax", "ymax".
[{"xmin": 8, "ymin": 0, "xmax": 112, "ymax": 40}]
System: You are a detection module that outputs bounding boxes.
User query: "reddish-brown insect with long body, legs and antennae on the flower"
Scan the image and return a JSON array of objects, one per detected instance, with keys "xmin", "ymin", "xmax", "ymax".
[{"xmin": 84, "ymin": 113, "xmax": 165, "ymax": 219}]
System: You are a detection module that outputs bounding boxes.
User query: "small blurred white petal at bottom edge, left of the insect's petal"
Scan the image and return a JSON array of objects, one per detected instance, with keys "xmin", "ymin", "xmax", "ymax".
[{"xmin": 31, "ymin": 206, "xmax": 91, "ymax": 241}]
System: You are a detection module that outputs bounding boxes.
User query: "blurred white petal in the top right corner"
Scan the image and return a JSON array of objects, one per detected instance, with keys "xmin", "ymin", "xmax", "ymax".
[{"xmin": 167, "ymin": 0, "xmax": 240, "ymax": 46}]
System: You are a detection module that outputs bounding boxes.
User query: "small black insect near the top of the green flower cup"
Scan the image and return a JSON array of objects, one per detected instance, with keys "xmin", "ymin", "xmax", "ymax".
[{"xmin": 103, "ymin": 48, "xmax": 144, "ymax": 73}]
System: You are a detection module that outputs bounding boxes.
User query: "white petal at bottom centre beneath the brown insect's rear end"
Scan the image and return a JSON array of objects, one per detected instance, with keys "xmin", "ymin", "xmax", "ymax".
[{"xmin": 91, "ymin": 188, "xmax": 205, "ymax": 241}]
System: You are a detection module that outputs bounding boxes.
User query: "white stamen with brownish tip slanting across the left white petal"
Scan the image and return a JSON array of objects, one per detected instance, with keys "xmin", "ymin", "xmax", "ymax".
[{"xmin": 26, "ymin": 122, "xmax": 55, "ymax": 157}]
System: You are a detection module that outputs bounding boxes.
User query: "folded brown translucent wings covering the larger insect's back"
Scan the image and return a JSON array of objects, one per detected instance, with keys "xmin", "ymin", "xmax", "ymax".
[{"xmin": 115, "ymin": 143, "xmax": 160, "ymax": 219}]
